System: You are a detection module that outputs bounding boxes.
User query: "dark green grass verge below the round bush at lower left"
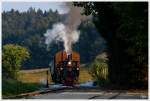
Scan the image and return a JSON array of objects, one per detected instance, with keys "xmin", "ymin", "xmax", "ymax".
[{"xmin": 2, "ymin": 79, "xmax": 41, "ymax": 97}]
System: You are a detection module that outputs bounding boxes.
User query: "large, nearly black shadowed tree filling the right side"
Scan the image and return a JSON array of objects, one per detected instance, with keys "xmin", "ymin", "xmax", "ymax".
[{"xmin": 74, "ymin": 2, "xmax": 148, "ymax": 87}]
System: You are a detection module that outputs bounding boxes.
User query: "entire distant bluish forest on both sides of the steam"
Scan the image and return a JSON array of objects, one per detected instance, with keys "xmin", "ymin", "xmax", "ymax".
[{"xmin": 2, "ymin": 8, "xmax": 105, "ymax": 68}]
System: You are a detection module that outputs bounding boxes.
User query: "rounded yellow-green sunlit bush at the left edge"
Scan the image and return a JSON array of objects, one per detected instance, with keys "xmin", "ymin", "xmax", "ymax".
[{"xmin": 2, "ymin": 44, "xmax": 29, "ymax": 79}]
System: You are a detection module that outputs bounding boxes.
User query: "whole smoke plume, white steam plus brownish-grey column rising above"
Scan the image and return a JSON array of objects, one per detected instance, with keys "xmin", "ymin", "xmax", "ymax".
[{"xmin": 44, "ymin": 2, "xmax": 87, "ymax": 54}]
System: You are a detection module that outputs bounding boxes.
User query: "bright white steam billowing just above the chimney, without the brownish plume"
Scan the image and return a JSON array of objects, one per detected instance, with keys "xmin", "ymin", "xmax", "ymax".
[{"xmin": 44, "ymin": 23, "xmax": 80, "ymax": 54}]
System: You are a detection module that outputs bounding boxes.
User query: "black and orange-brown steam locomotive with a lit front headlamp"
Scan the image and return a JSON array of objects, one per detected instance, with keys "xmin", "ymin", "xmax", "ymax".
[{"xmin": 51, "ymin": 51, "xmax": 80, "ymax": 86}]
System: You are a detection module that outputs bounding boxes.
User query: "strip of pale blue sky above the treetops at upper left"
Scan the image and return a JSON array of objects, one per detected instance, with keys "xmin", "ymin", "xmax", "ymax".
[{"xmin": 2, "ymin": 2, "xmax": 68, "ymax": 14}]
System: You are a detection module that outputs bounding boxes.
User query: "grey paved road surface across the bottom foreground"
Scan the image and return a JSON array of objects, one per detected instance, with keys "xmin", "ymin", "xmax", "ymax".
[{"xmin": 29, "ymin": 91, "xmax": 148, "ymax": 99}]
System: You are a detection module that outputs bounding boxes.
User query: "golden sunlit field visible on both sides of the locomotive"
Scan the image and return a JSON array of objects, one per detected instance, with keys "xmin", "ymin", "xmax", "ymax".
[{"xmin": 19, "ymin": 67, "xmax": 92, "ymax": 84}]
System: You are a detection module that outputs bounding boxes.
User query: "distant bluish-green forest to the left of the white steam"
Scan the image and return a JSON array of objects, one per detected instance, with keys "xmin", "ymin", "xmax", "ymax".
[{"xmin": 2, "ymin": 8, "xmax": 60, "ymax": 67}]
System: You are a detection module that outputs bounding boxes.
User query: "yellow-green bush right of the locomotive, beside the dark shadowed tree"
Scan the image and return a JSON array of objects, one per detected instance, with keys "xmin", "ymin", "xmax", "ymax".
[{"xmin": 89, "ymin": 60, "xmax": 108, "ymax": 86}]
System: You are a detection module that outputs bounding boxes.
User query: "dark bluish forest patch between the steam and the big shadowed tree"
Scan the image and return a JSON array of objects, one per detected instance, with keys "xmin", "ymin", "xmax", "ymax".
[{"xmin": 73, "ymin": 21, "xmax": 106, "ymax": 64}]
